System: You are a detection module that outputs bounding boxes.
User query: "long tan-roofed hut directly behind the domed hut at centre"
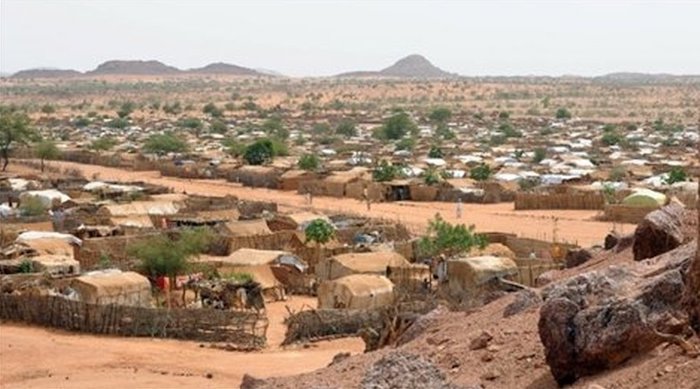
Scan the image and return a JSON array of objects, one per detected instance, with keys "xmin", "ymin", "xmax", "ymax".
[{"xmin": 316, "ymin": 251, "xmax": 410, "ymax": 281}]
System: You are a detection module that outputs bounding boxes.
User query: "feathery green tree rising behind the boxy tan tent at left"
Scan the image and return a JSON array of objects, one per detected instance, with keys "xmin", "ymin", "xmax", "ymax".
[{"xmin": 127, "ymin": 228, "xmax": 213, "ymax": 288}]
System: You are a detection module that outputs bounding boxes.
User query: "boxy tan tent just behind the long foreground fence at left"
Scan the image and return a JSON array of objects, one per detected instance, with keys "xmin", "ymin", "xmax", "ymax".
[{"xmin": 71, "ymin": 269, "xmax": 151, "ymax": 307}]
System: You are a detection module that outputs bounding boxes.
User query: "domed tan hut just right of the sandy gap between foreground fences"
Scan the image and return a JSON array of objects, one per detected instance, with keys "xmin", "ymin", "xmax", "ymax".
[{"xmin": 318, "ymin": 274, "xmax": 394, "ymax": 309}]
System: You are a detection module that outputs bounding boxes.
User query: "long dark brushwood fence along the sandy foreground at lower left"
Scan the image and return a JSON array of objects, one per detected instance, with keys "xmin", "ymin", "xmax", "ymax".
[{"xmin": 0, "ymin": 294, "xmax": 268, "ymax": 350}]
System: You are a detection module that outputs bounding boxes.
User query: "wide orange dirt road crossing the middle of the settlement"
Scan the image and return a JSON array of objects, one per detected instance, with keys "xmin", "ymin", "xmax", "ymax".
[{"xmin": 10, "ymin": 158, "xmax": 634, "ymax": 246}]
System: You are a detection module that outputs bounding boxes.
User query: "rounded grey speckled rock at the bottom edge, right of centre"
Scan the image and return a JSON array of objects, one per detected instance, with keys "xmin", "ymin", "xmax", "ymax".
[{"xmin": 360, "ymin": 350, "xmax": 458, "ymax": 389}]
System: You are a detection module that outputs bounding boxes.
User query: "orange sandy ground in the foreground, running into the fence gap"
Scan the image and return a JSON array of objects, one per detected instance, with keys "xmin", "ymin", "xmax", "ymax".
[{"xmin": 0, "ymin": 296, "xmax": 364, "ymax": 389}]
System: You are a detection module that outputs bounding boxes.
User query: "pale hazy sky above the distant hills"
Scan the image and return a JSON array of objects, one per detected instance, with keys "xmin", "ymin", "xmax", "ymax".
[{"xmin": 0, "ymin": 0, "xmax": 700, "ymax": 76}]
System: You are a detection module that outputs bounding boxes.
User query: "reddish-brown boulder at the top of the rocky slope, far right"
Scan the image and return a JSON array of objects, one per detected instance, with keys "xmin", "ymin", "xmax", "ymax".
[{"xmin": 632, "ymin": 204, "xmax": 685, "ymax": 261}]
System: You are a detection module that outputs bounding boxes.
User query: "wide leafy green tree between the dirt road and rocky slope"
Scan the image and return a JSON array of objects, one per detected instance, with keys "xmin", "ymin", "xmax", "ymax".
[{"xmin": 418, "ymin": 213, "xmax": 488, "ymax": 258}]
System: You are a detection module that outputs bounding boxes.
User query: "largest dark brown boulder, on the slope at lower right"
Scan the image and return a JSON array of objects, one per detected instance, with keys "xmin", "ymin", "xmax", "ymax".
[{"xmin": 538, "ymin": 242, "xmax": 696, "ymax": 385}]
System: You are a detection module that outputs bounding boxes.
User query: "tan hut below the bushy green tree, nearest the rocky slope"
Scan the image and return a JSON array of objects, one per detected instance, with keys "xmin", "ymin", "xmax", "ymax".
[{"xmin": 447, "ymin": 256, "xmax": 518, "ymax": 295}]
